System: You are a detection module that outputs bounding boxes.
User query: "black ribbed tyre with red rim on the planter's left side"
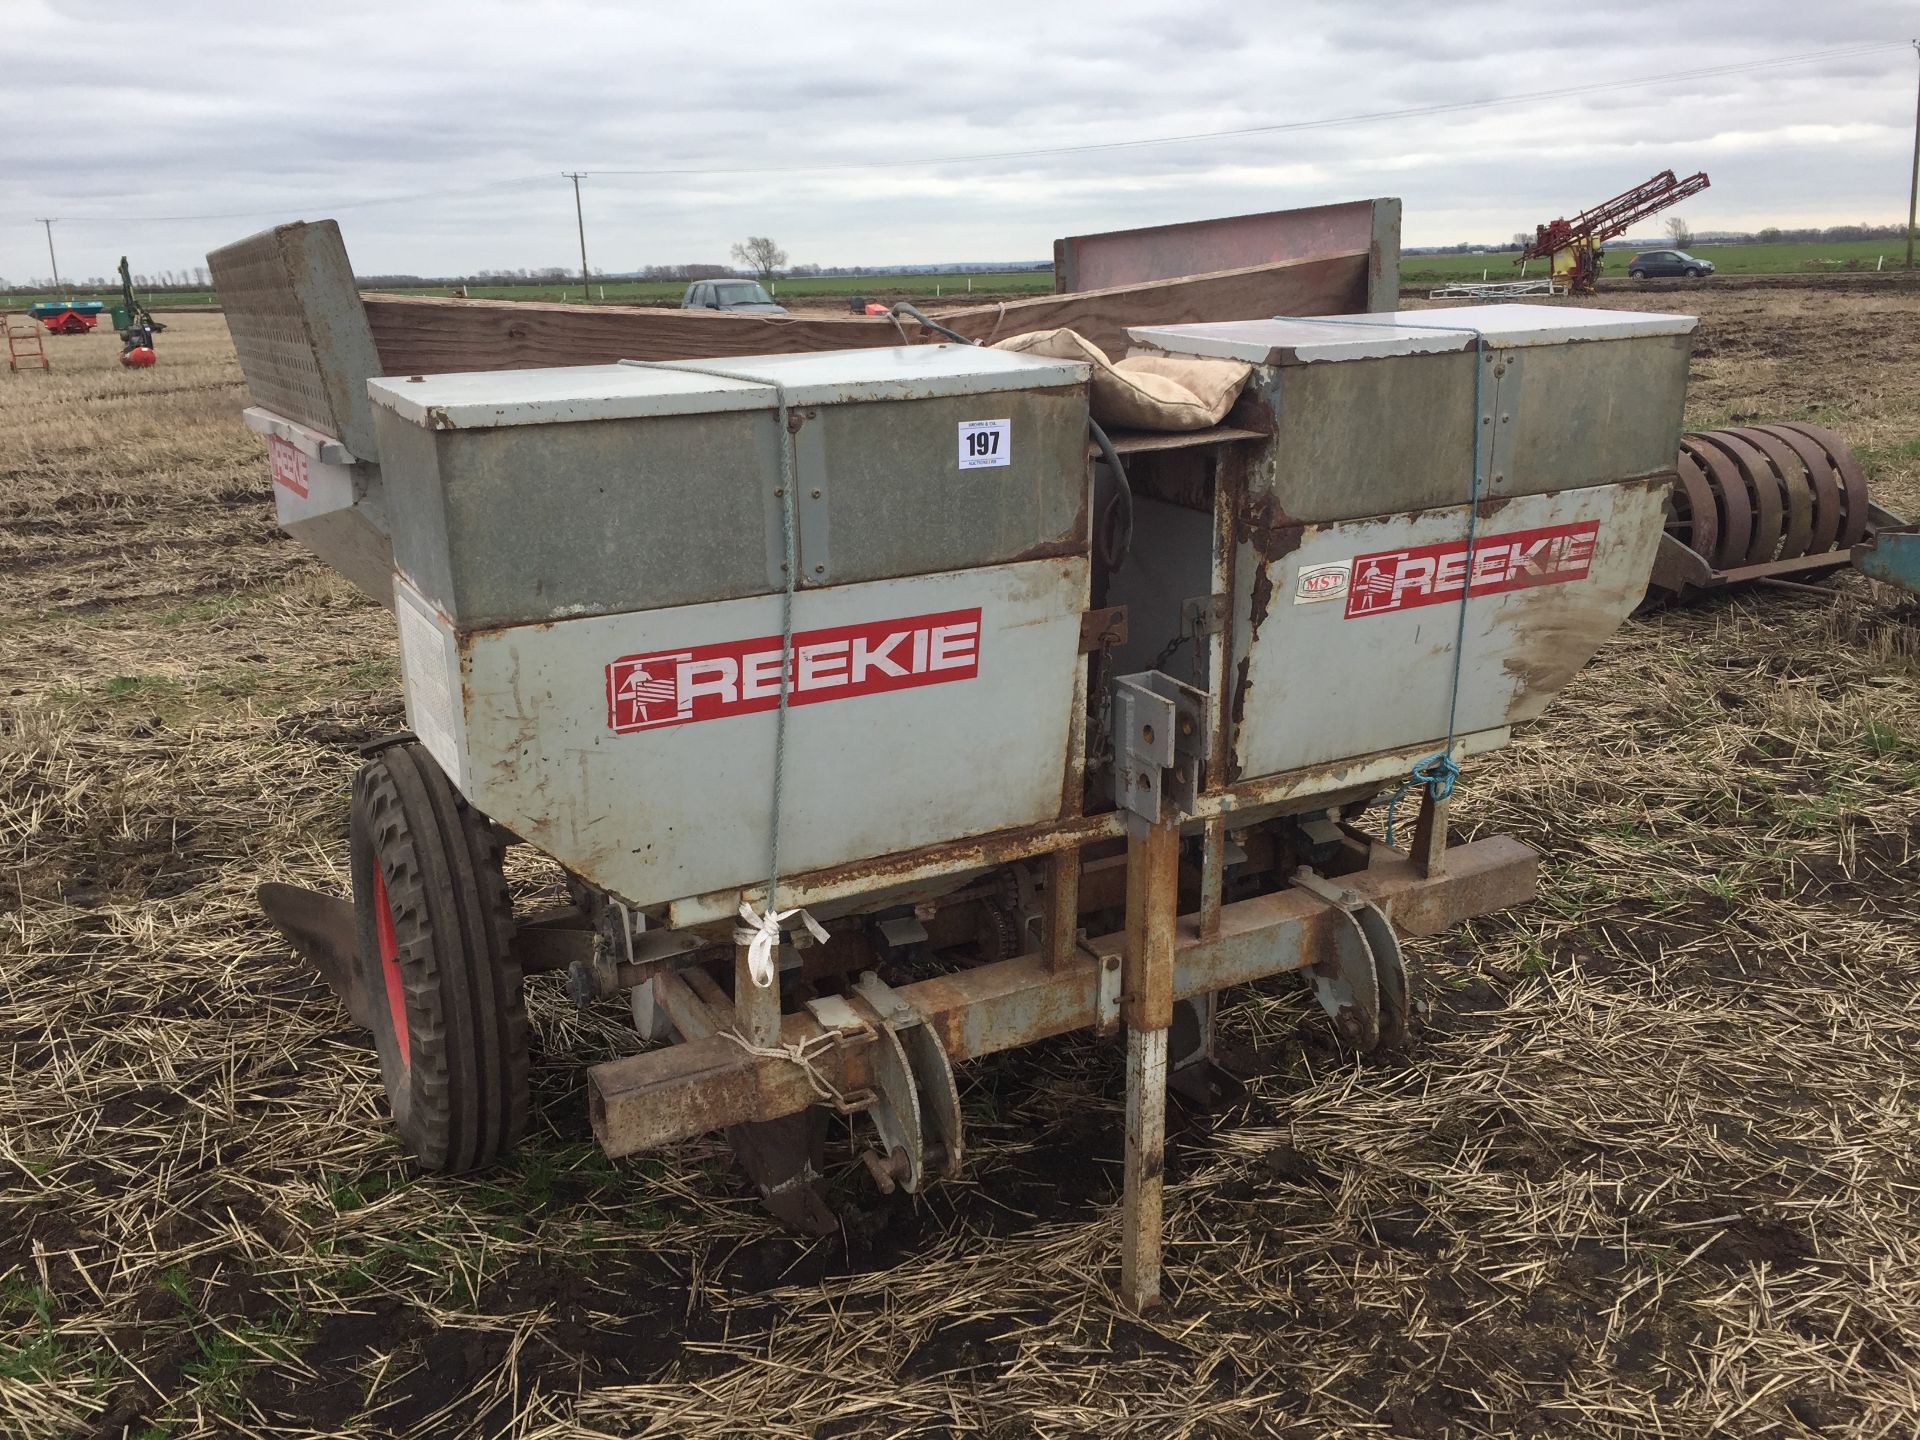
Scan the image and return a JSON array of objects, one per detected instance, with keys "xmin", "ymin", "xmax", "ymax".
[{"xmin": 351, "ymin": 741, "xmax": 528, "ymax": 1173}]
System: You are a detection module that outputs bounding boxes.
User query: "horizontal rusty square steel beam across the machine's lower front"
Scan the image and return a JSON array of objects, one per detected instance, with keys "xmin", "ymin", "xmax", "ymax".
[{"xmin": 588, "ymin": 835, "xmax": 1540, "ymax": 1158}]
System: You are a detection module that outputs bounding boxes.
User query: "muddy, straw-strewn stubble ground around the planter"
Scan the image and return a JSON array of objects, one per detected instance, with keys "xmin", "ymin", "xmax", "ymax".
[{"xmin": 0, "ymin": 286, "xmax": 1920, "ymax": 1436}]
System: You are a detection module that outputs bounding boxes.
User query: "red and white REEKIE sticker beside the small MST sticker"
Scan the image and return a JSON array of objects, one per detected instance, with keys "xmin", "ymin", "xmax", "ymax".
[{"xmin": 1346, "ymin": 520, "xmax": 1599, "ymax": 620}]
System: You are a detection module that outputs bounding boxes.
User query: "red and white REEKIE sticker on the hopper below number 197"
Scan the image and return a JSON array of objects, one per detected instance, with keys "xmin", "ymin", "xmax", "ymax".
[{"xmin": 607, "ymin": 609, "xmax": 979, "ymax": 735}]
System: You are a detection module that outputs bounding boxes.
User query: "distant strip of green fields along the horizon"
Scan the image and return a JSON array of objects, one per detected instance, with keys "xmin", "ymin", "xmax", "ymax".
[{"xmin": 0, "ymin": 240, "xmax": 1907, "ymax": 311}]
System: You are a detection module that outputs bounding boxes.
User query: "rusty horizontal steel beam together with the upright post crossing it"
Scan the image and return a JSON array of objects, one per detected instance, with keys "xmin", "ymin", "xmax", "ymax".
[{"xmin": 588, "ymin": 822, "xmax": 1538, "ymax": 1306}]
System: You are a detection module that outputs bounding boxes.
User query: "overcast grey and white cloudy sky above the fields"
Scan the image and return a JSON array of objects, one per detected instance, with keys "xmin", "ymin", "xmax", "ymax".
[{"xmin": 0, "ymin": 0, "xmax": 1920, "ymax": 282}]
